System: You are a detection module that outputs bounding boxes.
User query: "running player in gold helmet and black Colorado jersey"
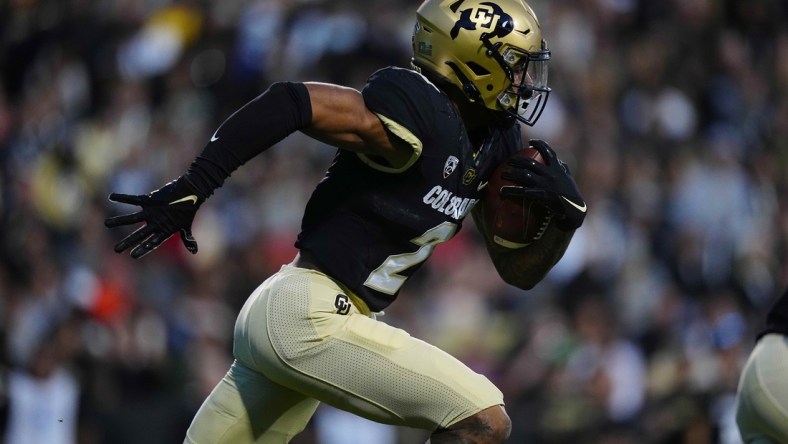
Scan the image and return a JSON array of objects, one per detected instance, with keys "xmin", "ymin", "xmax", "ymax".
[{"xmin": 106, "ymin": 0, "xmax": 586, "ymax": 444}]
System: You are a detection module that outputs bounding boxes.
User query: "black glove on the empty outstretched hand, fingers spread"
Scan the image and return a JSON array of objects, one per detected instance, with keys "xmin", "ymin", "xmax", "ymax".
[{"xmin": 104, "ymin": 177, "xmax": 205, "ymax": 259}]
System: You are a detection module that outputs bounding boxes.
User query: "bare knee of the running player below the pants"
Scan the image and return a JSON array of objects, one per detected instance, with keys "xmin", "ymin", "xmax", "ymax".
[{"xmin": 430, "ymin": 406, "xmax": 512, "ymax": 444}]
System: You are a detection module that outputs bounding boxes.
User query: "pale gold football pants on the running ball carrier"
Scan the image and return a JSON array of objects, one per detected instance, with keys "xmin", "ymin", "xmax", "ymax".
[{"xmin": 185, "ymin": 265, "xmax": 503, "ymax": 444}]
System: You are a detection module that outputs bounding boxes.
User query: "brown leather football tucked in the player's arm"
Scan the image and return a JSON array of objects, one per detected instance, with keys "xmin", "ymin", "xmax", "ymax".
[{"xmin": 481, "ymin": 147, "xmax": 552, "ymax": 249}]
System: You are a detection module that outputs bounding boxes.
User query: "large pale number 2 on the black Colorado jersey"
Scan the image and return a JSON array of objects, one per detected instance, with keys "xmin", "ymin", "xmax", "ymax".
[{"xmin": 364, "ymin": 222, "xmax": 457, "ymax": 295}]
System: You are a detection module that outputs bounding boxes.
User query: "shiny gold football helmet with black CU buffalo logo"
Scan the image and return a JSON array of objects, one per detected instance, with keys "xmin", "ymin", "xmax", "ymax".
[{"xmin": 413, "ymin": 0, "xmax": 550, "ymax": 125}]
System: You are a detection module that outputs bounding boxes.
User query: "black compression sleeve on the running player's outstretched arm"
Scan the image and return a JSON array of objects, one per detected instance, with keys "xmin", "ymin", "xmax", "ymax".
[{"xmin": 185, "ymin": 82, "xmax": 312, "ymax": 198}]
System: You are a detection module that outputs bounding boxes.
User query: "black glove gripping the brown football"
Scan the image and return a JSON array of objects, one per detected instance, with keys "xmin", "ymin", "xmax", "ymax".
[{"xmin": 501, "ymin": 139, "xmax": 587, "ymax": 231}]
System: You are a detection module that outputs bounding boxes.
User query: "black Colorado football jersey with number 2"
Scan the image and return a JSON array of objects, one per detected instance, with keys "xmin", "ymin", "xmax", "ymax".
[{"xmin": 296, "ymin": 68, "xmax": 522, "ymax": 311}]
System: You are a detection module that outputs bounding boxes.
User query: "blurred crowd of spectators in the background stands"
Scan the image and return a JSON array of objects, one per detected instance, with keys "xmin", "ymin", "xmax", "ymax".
[{"xmin": 0, "ymin": 0, "xmax": 788, "ymax": 444}]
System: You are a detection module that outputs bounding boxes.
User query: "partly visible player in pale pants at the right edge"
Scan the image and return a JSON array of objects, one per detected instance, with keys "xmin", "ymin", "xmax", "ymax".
[{"xmin": 736, "ymin": 289, "xmax": 788, "ymax": 444}]
